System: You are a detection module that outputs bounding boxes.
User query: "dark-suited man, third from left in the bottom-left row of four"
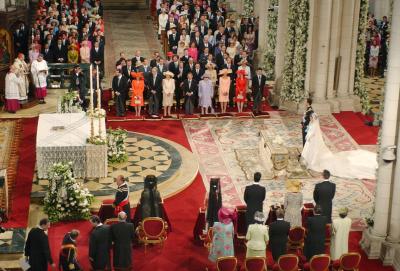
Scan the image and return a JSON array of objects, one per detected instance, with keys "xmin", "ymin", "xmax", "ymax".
[{"xmin": 89, "ymin": 215, "xmax": 111, "ymax": 270}]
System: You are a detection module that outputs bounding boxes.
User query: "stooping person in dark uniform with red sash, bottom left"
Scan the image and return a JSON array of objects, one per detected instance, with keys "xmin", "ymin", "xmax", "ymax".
[{"xmin": 59, "ymin": 230, "xmax": 82, "ymax": 271}]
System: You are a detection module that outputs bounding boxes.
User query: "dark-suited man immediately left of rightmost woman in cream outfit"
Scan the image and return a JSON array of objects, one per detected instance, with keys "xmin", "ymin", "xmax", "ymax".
[{"xmin": 304, "ymin": 205, "xmax": 328, "ymax": 261}]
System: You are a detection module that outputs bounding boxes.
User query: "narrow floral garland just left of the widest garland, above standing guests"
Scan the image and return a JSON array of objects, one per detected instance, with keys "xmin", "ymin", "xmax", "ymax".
[{"xmin": 263, "ymin": 0, "xmax": 279, "ymax": 80}]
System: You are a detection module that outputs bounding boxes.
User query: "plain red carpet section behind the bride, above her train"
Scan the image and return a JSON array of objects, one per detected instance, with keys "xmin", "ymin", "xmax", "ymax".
[{"xmin": 333, "ymin": 112, "xmax": 379, "ymax": 145}]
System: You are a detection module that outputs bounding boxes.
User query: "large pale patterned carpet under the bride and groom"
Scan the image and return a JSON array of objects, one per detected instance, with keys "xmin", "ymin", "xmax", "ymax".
[{"xmin": 184, "ymin": 112, "xmax": 375, "ymax": 230}]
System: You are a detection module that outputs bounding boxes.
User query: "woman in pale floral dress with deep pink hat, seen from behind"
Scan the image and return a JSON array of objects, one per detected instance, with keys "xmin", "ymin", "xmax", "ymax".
[{"xmin": 208, "ymin": 207, "xmax": 236, "ymax": 262}]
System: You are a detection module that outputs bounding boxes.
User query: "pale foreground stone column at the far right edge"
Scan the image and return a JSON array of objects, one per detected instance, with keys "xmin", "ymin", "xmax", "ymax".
[{"xmin": 361, "ymin": 1, "xmax": 400, "ymax": 259}]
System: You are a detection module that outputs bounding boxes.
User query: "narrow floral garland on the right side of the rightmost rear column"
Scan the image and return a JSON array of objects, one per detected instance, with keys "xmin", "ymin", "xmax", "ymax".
[{"xmin": 354, "ymin": 0, "xmax": 371, "ymax": 113}]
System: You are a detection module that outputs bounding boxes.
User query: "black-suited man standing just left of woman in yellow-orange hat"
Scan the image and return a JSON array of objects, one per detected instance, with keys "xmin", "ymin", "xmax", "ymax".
[{"xmin": 244, "ymin": 172, "xmax": 266, "ymax": 227}]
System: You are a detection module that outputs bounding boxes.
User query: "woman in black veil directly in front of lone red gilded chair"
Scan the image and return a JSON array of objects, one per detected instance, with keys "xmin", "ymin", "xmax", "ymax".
[{"xmin": 140, "ymin": 175, "xmax": 164, "ymax": 220}]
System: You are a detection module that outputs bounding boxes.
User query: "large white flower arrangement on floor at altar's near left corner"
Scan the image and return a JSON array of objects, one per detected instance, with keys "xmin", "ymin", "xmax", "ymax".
[{"xmin": 44, "ymin": 162, "xmax": 93, "ymax": 222}]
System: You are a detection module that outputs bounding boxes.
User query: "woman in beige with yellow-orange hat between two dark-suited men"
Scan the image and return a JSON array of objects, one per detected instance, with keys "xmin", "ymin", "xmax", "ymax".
[{"xmin": 284, "ymin": 180, "xmax": 303, "ymax": 228}]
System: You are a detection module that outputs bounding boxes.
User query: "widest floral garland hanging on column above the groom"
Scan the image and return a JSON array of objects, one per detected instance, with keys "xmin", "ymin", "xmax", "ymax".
[{"xmin": 281, "ymin": 0, "xmax": 309, "ymax": 103}]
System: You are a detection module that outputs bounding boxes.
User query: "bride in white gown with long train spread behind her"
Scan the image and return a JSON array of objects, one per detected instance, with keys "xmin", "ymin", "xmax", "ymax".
[{"xmin": 301, "ymin": 114, "xmax": 378, "ymax": 179}]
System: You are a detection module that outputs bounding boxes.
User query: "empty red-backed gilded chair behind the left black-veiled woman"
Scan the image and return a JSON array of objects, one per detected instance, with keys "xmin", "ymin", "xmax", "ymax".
[{"xmin": 137, "ymin": 217, "xmax": 168, "ymax": 253}]
